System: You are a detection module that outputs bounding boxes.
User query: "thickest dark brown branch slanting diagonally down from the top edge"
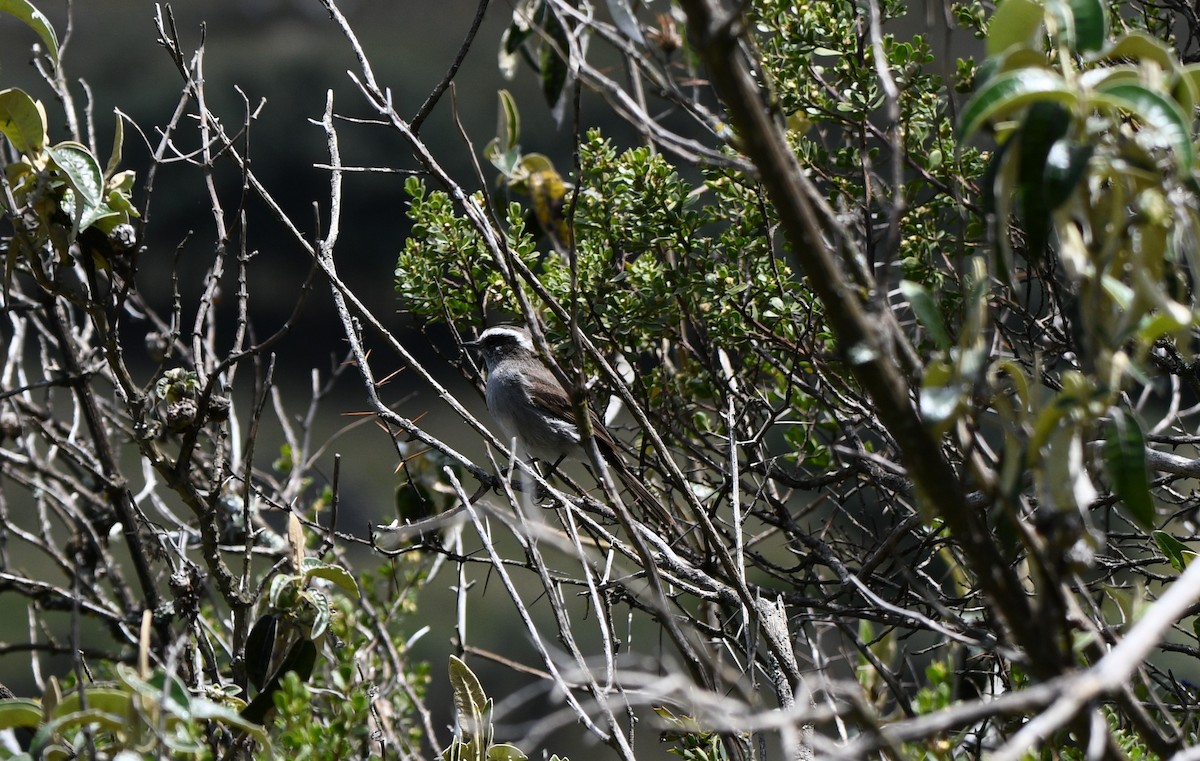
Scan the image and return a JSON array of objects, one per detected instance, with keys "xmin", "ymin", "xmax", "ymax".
[{"xmin": 680, "ymin": 0, "xmax": 1058, "ymax": 675}]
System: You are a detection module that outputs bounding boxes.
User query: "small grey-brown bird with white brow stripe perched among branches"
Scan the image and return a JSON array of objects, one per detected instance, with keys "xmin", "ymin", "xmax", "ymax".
[{"xmin": 464, "ymin": 325, "xmax": 674, "ymax": 526}]
